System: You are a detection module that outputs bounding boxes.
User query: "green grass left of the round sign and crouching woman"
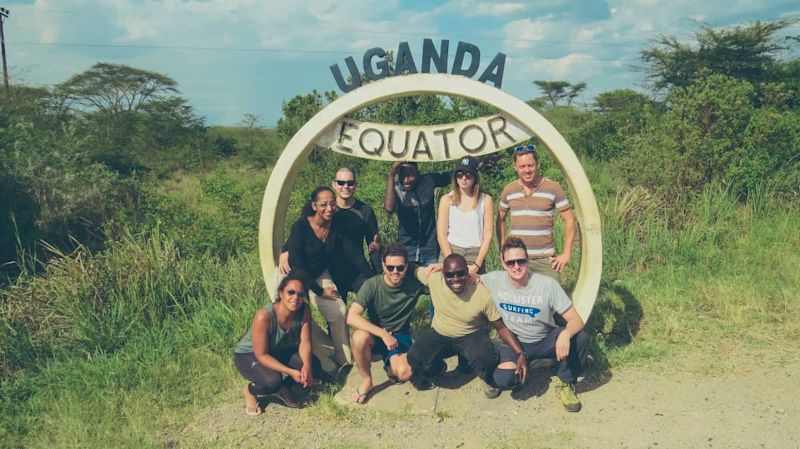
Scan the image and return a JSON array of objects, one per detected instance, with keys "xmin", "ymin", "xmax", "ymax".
[{"xmin": 0, "ymin": 233, "xmax": 268, "ymax": 447}]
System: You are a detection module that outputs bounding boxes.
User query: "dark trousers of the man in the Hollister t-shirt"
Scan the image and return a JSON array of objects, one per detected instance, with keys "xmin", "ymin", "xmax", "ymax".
[{"xmin": 494, "ymin": 327, "xmax": 589, "ymax": 389}]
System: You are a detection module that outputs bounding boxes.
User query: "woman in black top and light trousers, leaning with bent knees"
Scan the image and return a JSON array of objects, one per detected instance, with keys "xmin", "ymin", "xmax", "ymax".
[{"xmin": 288, "ymin": 187, "xmax": 371, "ymax": 365}]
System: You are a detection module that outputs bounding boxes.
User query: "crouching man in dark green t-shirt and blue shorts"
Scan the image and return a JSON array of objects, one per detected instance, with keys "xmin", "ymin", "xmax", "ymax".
[{"xmin": 347, "ymin": 243, "xmax": 425, "ymax": 404}]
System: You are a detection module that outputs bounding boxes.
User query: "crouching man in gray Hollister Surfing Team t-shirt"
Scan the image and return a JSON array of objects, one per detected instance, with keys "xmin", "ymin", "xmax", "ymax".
[{"xmin": 481, "ymin": 237, "xmax": 589, "ymax": 412}]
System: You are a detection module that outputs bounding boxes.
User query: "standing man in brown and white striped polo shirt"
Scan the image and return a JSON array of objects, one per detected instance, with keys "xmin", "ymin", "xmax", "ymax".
[{"xmin": 497, "ymin": 145, "xmax": 575, "ymax": 281}]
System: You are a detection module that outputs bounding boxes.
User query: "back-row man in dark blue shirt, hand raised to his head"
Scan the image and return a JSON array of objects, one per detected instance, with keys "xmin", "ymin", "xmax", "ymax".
[{"xmin": 383, "ymin": 161, "xmax": 450, "ymax": 266}]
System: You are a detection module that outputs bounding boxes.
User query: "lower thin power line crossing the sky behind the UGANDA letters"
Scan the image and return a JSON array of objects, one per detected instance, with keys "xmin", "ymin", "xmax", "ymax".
[{"xmin": 14, "ymin": 42, "xmax": 629, "ymax": 61}]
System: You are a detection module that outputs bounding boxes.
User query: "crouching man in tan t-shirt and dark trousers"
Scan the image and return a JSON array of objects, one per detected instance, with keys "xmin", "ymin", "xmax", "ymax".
[{"xmin": 408, "ymin": 254, "xmax": 528, "ymax": 398}]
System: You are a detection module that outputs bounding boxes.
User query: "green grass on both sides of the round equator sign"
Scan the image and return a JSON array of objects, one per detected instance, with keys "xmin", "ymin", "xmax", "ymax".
[{"xmin": 0, "ymin": 153, "xmax": 800, "ymax": 448}]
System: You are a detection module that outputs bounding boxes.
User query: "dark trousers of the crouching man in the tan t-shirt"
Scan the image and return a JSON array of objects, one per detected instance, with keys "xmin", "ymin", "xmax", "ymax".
[{"xmin": 408, "ymin": 329, "xmax": 497, "ymax": 383}]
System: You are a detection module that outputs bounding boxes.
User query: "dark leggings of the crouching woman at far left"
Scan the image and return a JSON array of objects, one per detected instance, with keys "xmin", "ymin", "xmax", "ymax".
[{"xmin": 233, "ymin": 349, "xmax": 322, "ymax": 395}]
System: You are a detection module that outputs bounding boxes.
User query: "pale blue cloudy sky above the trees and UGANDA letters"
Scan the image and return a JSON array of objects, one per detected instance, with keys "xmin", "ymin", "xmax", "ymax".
[{"xmin": 0, "ymin": 0, "xmax": 800, "ymax": 126}]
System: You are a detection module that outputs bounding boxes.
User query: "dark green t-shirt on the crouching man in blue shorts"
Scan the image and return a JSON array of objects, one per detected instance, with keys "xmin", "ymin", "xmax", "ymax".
[{"xmin": 355, "ymin": 273, "xmax": 425, "ymax": 333}]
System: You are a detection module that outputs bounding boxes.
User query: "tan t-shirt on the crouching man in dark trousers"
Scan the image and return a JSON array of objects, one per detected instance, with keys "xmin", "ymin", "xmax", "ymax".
[{"xmin": 417, "ymin": 270, "xmax": 500, "ymax": 338}]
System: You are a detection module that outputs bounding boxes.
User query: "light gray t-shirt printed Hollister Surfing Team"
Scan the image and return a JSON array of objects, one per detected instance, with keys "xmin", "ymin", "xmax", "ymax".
[{"xmin": 481, "ymin": 271, "xmax": 572, "ymax": 343}]
